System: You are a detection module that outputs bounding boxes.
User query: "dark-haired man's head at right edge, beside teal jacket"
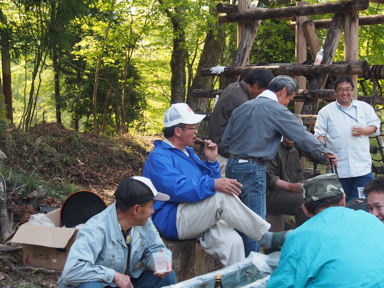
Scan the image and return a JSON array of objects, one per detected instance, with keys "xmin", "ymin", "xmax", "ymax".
[{"xmin": 364, "ymin": 178, "xmax": 384, "ymax": 223}]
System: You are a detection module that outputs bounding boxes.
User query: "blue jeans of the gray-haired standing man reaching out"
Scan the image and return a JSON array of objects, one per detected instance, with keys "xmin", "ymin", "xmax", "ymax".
[{"xmin": 225, "ymin": 158, "xmax": 267, "ymax": 257}]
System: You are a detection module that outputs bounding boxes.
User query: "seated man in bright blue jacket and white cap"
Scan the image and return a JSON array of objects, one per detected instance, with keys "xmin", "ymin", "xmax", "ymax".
[{"xmin": 143, "ymin": 103, "xmax": 286, "ymax": 265}]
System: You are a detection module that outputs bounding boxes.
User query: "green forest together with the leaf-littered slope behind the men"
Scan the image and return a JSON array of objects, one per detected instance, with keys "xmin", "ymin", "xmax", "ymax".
[{"xmin": 0, "ymin": 0, "xmax": 384, "ymax": 287}]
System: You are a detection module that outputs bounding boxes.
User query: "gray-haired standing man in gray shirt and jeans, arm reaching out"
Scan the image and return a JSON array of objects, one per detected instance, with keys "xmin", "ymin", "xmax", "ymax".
[{"xmin": 222, "ymin": 75, "xmax": 337, "ymax": 256}]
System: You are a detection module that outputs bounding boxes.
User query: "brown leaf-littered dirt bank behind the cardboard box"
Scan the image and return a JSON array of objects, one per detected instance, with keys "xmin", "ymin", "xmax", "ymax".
[{"xmin": 0, "ymin": 123, "xmax": 162, "ymax": 287}]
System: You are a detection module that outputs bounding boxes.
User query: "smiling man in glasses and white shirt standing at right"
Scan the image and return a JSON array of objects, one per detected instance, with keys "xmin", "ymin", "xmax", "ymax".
[{"xmin": 315, "ymin": 76, "xmax": 380, "ymax": 201}]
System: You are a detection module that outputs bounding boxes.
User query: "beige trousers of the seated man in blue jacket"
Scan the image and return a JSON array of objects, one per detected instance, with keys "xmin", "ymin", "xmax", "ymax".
[{"xmin": 176, "ymin": 192, "xmax": 271, "ymax": 266}]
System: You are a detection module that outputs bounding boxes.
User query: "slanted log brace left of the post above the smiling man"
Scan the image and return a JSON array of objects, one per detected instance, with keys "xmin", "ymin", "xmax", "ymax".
[{"xmin": 301, "ymin": 13, "xmax": 348, "ymax": 115}]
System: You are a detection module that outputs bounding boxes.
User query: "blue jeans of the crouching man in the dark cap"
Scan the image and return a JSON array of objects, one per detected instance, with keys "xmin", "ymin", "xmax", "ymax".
[{"xmin": 78, "ymin": 270, "xmax": 176, "ymax": 288}]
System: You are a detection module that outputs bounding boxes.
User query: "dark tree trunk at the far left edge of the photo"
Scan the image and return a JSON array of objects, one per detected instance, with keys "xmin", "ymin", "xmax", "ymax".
[{"xmin": 0, "ymin": 9, "xmax": 13, "ymax": 123}]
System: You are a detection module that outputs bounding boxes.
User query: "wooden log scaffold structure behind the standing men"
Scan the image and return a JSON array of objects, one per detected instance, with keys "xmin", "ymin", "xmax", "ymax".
[{"xmin": 192, "ymin": 0, "xmax": 384, "ymax": 174}]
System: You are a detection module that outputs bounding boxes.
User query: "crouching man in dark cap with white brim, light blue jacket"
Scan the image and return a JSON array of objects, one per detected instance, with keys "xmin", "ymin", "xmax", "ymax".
[{"xmin": 59, "ymin": 176, "xmax": 176, "ymax": 288}]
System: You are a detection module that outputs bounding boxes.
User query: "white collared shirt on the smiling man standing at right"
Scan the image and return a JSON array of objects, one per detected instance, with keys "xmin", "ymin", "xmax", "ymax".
[{"xmin": 315, "ymin": 100, "xmax": 380, "ymax": 178}]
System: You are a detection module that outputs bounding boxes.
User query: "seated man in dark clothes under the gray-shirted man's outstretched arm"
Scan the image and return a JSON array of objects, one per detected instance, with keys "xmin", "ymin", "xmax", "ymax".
[{"xmin": 265, "ymin": 115, "xmax": 308, "ymax": 227}]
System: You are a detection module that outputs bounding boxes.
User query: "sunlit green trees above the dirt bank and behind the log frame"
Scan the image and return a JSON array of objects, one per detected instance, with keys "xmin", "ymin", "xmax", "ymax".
[{"xmin": 0, "ymin": 0, "xmax": 384, "ymax": 136}]
